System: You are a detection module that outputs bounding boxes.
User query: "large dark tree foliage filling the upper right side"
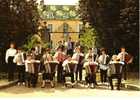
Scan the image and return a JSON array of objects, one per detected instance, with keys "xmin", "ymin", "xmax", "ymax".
[{"xmin": 79, "ymin": 0, "xmax": 139, "ymax": 69}]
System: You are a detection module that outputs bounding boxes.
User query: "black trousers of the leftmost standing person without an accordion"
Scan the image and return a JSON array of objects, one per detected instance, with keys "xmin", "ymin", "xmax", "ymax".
[{"xmin": 8, "ymin": 57, "xmax": 16, "ymax": 81}]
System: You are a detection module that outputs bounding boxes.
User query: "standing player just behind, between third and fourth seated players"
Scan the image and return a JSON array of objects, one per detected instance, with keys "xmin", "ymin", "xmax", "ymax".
[{"xmin": 72, "ymin": 47, "xmax": 84, "ymax": 81}]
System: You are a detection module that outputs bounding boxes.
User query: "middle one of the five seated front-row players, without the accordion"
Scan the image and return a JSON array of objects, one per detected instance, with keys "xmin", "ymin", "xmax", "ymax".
[{"xmin": 62, "ymin": 55, "xmax": 78, "ymax": 83}]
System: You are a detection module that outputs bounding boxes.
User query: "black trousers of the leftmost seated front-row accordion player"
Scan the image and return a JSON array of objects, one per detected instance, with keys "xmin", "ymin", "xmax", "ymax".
[{"xmin": 26, "ymin": 72, "xmax": 37, "ymax": 87}]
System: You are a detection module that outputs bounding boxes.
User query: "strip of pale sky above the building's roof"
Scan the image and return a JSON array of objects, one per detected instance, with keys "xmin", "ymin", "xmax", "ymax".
[{"xmin": 38, "ymin": 0, "xmax": 79, "ymax": 5}]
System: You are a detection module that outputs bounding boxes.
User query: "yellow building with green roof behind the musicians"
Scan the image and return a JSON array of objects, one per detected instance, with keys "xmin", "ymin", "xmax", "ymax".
[{"xmin": 37, "ymin": 5, "xmax": 82, "ymax": 45}]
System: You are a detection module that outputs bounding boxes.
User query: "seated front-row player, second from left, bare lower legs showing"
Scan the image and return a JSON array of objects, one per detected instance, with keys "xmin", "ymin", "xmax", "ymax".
[{"xmin": 41, "ymin": 49, "xmax": 54, "ymax": 88}]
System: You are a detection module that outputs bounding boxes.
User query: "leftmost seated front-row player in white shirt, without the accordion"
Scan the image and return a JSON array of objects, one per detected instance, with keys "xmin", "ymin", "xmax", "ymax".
[{"xmin": 25, "ymin": 54, "xmax": 40, "ymax": 87}]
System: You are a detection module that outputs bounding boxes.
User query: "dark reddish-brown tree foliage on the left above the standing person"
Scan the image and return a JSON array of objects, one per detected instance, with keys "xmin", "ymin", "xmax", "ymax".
[{"xmin": 0, "ymin": 0, "xmax": 39, "ymax": 47}]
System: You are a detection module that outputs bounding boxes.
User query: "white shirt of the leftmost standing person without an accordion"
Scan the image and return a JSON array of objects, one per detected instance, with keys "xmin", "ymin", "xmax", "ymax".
[{"xmin": 5, "ymin": 48, "xmax": 17, "ymax": 63}]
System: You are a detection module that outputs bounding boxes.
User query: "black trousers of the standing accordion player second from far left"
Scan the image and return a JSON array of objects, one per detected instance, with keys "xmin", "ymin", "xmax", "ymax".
[{"xmin": 17, "ymin": 65, "xmax": 25, "ymax": 82}]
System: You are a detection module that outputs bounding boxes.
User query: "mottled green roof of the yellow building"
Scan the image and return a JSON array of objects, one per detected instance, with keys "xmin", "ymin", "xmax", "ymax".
[{"xmin": 38, "ymin": 5, "xmax": 79, "ymax": 20}]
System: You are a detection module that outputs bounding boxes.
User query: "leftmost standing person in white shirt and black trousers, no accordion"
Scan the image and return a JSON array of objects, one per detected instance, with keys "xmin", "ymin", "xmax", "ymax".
[{"xmin": 5, "ymin": 43, "xmax": 17, "ymax": 81}]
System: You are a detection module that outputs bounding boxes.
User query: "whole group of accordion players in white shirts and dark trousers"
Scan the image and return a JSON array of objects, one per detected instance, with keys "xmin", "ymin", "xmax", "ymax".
[{"xmin": 6, "ymin": 41, "xmax": 132, "ymax": 90}]
